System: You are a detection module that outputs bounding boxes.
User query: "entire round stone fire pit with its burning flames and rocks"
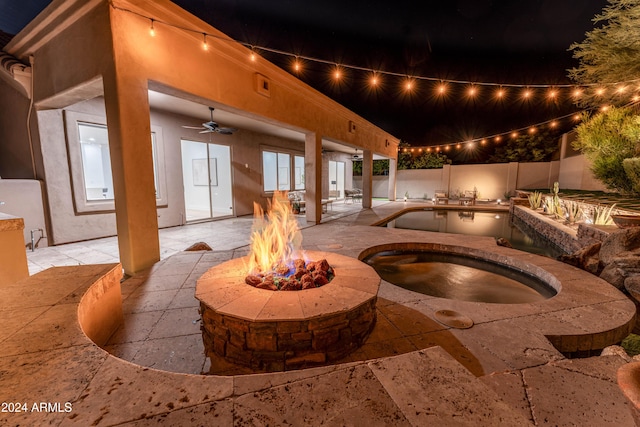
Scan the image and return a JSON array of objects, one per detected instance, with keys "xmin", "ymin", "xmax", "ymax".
[{"xmin": 196, "ymin": 193, "xmax": 380, "ymax": 371}]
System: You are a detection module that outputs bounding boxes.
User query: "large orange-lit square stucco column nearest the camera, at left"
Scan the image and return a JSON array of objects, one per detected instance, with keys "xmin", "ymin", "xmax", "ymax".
[{"xmin": 103, "ymin": 72, "xmax": 160, "ymax": 274}]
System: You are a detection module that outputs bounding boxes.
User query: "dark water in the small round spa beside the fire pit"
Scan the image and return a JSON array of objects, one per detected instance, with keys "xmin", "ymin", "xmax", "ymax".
[{"xmin": 362, "ymin": 250, "xmax": 556, "ymax": 304}]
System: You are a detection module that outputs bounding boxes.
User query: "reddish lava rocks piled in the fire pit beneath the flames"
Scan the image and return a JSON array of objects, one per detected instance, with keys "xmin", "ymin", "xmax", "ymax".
[{"xmin": 244, "ymin": 259, "xmax": 335, "ymax": 291}]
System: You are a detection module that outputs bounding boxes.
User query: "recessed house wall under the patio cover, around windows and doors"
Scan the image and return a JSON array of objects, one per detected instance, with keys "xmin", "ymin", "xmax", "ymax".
[{"xmin": 38, "ymin": 98, "xmax": 312, "ymax": 244}]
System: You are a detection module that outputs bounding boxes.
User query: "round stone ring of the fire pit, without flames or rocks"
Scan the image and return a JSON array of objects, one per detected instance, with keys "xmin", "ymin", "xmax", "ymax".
[{"xmin": 196, "ymin": 252, "xmax": 380, "ymax": 371}]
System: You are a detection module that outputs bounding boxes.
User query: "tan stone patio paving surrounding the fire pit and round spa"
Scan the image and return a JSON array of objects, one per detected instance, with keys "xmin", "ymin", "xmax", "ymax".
[{"xmin": 0, "ymin": 204, "xmax": 635, "ymax": 426}]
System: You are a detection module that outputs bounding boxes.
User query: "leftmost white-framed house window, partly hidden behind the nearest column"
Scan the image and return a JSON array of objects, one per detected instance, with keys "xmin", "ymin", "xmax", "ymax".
[{"xmin": 65, "ymin": 111, "xmax": 167, "ymax": 213}]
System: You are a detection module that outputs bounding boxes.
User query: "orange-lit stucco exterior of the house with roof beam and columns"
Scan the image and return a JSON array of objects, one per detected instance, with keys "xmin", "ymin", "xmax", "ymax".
[{"xmin": 5, "ymin": 0, "xmax": 399, "ymax": 273}]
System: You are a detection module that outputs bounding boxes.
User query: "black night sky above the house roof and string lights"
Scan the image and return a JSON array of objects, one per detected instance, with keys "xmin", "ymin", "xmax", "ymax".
[{"xmin": 0, "ymin": 0, "xmax": 607, "ymax": 153}]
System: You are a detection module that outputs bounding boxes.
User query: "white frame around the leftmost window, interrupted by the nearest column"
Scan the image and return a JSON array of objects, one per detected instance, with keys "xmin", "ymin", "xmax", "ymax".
[{"xmin": 64, "ymin": 110, "xmax": 168, "ymax": 213}]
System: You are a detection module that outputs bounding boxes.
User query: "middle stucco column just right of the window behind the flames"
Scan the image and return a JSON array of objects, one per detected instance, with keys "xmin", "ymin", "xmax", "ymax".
[{"xmin": 304, "ymin": 133, "xmax": 322, "ymax": 224}]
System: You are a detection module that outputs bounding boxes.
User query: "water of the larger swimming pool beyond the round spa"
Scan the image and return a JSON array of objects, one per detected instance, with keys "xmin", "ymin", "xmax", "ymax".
[{"xmin": 383, "ymin": 209, "xmax": 564, "ymax": 258}]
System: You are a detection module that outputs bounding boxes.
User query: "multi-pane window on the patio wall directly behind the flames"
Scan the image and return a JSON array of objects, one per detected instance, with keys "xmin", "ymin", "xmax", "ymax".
[{"xmin": 262, "ymin": 150, "xmax": 304, "ymax": 192}]
